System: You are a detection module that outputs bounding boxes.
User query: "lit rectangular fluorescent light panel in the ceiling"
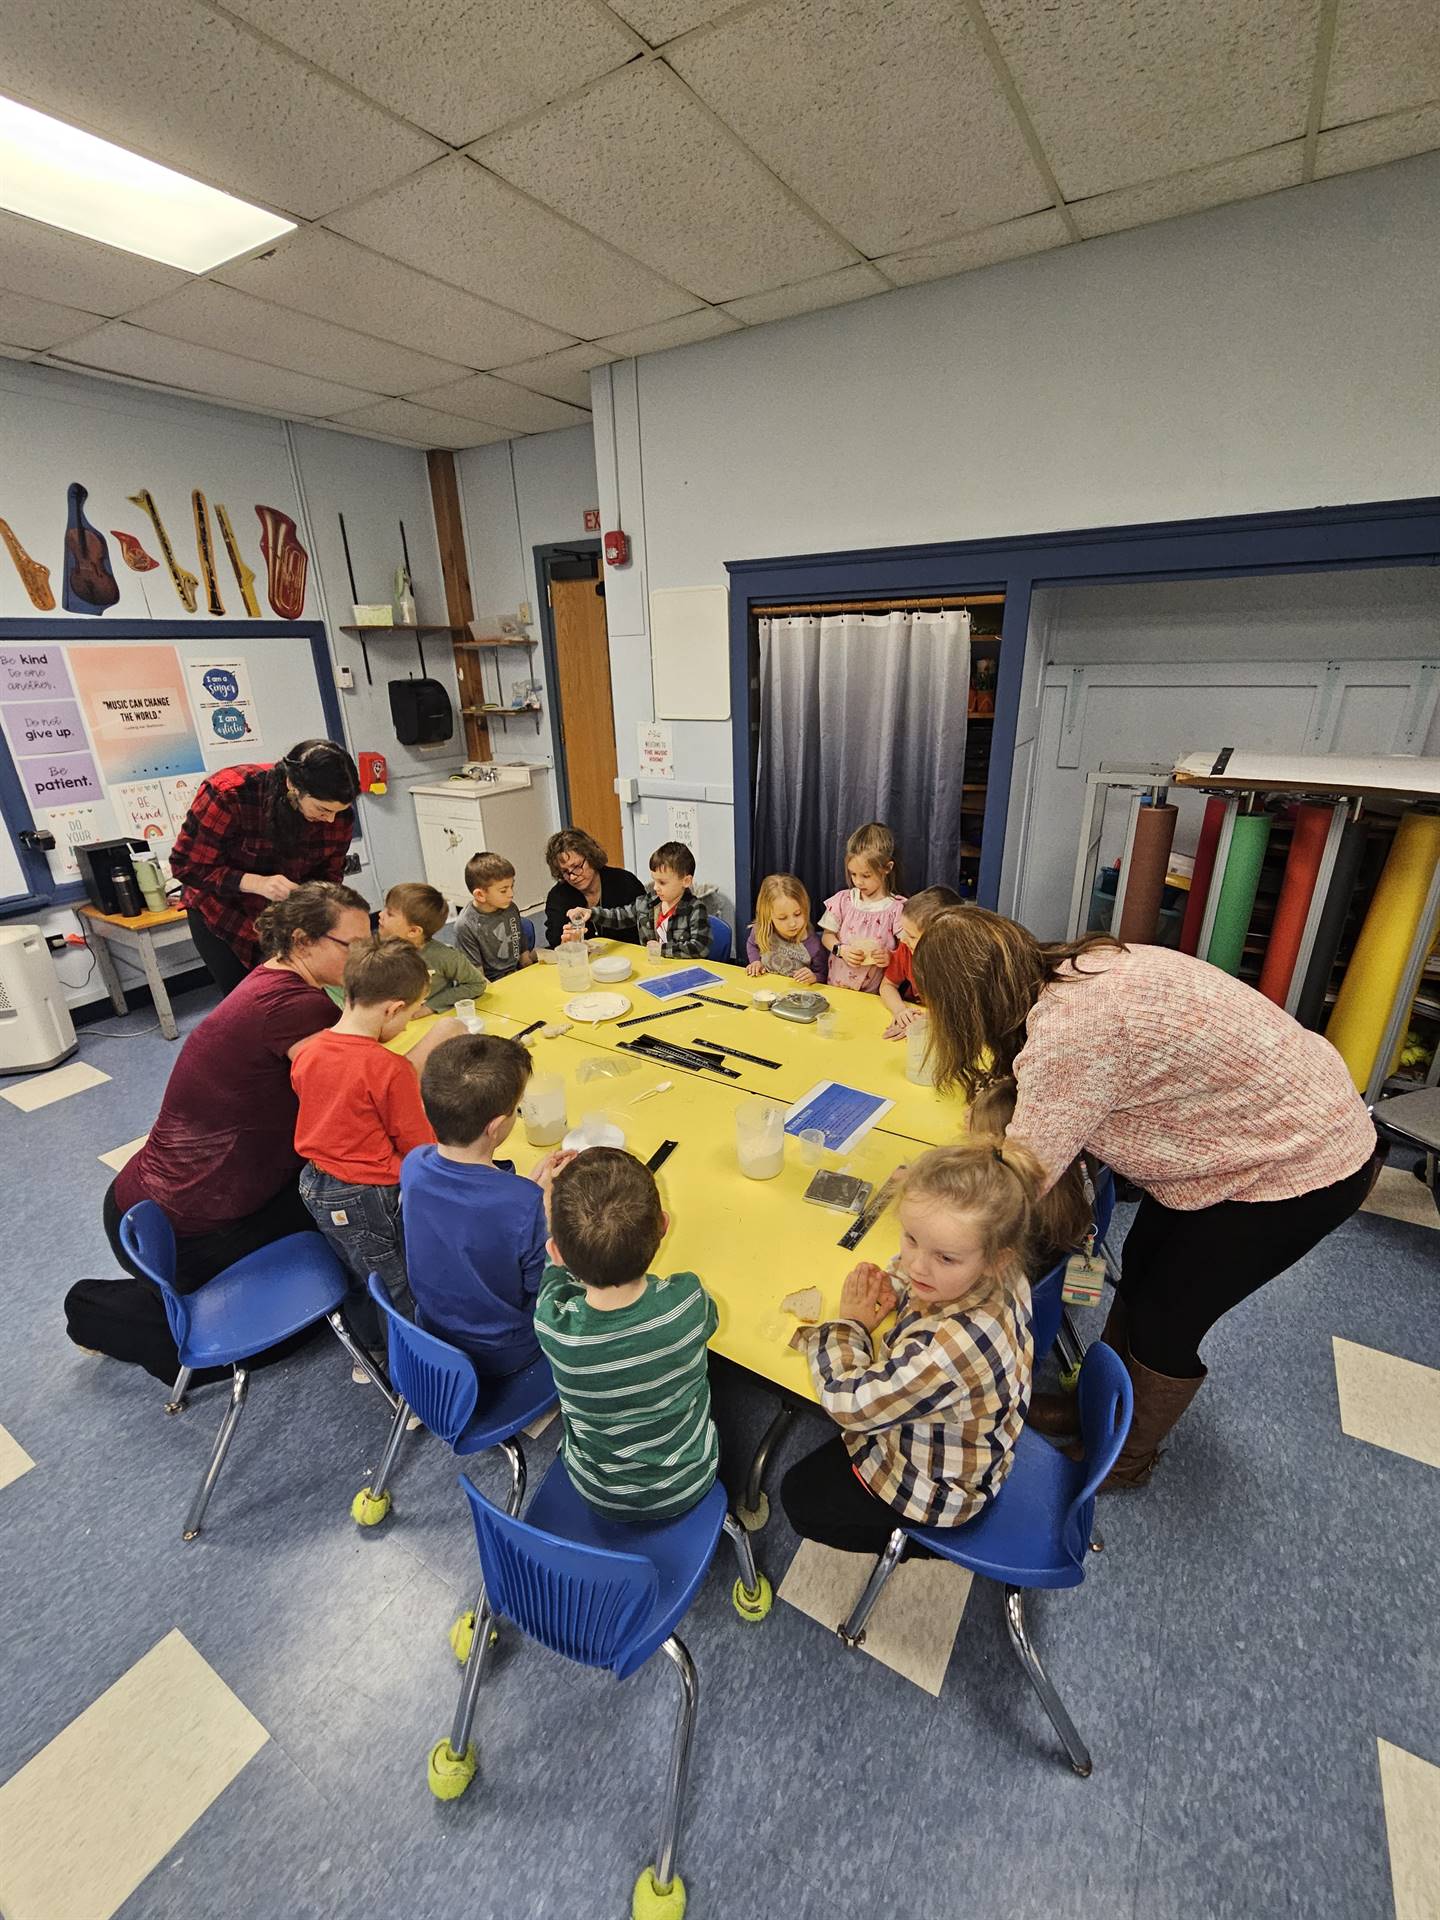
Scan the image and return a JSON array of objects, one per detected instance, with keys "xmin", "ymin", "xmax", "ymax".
[{"xmin": 0, "ymin": 98, "xmax": 296, "ymax": 273}]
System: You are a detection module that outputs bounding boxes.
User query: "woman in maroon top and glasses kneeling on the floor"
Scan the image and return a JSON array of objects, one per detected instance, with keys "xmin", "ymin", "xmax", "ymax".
[{"xmin": 65, "ymin": 881, "xmax": 371, "ymax": 1382}]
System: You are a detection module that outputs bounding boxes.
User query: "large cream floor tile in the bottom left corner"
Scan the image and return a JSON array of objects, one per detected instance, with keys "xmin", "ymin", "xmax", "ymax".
[{"xmin": 0, "ymin": 1630, "xmax": 271, "ymax": 1920}]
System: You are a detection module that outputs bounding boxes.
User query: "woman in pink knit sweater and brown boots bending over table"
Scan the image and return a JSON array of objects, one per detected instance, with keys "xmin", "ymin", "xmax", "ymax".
[{"xmin": 914, "ymin": 906, "xmax": 1375, "ymax": 1488}]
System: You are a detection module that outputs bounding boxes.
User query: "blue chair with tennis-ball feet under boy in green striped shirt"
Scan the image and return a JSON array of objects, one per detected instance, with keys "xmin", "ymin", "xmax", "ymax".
[{"xmin": 430, "ymin": 1457, "xmax": 774, "ymax": 1920}]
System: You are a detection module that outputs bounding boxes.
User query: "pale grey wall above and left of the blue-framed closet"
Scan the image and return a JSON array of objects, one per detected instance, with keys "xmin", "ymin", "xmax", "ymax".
[{"xmin": 591, "ymin": 154, "xmax": 1440, "ymax": 910}]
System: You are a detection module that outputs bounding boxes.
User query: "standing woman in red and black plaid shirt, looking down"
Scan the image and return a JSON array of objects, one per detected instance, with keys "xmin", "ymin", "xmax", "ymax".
[{"xmin": 171, "ymin": 739, "xmax": 359, "ymax": 993}]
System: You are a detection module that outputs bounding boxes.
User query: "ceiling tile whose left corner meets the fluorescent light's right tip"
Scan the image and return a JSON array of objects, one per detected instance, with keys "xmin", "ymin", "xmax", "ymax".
[{"xmin": 326, "ymin": 154, "xmax": 697, "ymax": 340}]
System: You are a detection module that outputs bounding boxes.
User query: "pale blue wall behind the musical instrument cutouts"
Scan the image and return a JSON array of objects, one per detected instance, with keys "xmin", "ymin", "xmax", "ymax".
[{"xmin": 0, "ymin": 361, "xmax": 463, "ymax": 1006}]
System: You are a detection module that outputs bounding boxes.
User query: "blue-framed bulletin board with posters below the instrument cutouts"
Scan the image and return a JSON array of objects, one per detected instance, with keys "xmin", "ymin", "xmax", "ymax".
[{"xmin": 0, "ymin": 620, "xmax": 344, "ymax": 914}]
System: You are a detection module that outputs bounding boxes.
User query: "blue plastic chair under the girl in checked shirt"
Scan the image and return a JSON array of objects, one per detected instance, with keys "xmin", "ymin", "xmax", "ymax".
[{"xmin": 839, "ymin": 1340, "xmax": 1133, "ymax": 1778}]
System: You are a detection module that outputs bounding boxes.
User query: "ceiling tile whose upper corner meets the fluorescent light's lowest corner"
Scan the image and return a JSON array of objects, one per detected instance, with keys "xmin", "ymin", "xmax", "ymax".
[{"xmin": 129, "ymin": 280, "xmax": 461, "ymax": 394}]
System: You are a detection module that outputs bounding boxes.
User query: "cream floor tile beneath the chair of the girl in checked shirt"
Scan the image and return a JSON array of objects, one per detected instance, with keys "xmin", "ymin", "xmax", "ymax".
[{"xmin": 780, "ymin": 1540, "xmax": 972, "ymax": 1697}]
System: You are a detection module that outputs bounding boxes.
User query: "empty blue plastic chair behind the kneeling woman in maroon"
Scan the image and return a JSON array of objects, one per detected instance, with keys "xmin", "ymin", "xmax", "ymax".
[{"xmin": 119, "ymin": 1200, "xmax": 394, "ymax": 1540}]
